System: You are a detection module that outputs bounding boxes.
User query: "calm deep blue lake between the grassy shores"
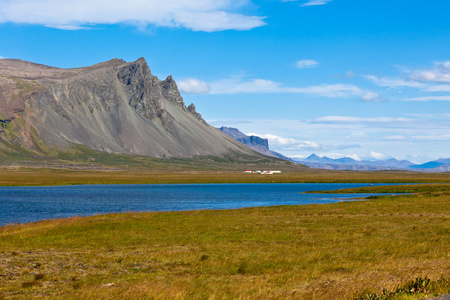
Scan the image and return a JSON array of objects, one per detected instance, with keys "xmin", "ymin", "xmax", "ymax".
[{"xmin": 0, "ymin": 183, "xmax": 394, "ymax": 226}]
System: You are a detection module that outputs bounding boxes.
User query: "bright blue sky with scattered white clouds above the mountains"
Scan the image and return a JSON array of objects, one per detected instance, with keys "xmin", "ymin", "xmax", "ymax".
[{"xmin": 0, "ymin": 0, "xmax": 450, "ymax": 163}]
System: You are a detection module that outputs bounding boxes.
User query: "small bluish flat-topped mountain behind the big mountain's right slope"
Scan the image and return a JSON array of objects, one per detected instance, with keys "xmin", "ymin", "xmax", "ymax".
[{"xmin": 219, "ymin": 126, "xmax": 291, "ymax": 160}]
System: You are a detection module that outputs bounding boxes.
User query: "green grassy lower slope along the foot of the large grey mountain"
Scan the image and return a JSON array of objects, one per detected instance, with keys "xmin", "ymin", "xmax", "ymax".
[{"xmin": 0, "ymin": 137, "xmax": 298, "ymax": 171}]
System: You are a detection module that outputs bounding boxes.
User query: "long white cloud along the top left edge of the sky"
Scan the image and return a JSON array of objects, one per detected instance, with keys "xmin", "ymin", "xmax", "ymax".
[{"xmin": 0, "ymin": 0, "xmax": 265, "ymax": 32}]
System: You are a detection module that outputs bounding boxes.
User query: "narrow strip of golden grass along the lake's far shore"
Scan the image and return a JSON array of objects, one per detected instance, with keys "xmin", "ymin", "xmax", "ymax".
[{"xmin": 0, "ymin": 165, "xmax": 450, "ymax": 186}]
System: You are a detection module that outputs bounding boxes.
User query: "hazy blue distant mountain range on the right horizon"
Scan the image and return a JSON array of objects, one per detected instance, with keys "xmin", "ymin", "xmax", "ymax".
[{"xmin": 292, "ymin": 154, "xmax": 450, "ymax": 172}]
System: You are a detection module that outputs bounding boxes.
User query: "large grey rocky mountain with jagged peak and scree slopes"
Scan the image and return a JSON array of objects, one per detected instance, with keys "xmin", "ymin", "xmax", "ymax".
[{"xmin": 0, "ymin": 58, "xmax": 268, "ymax": 163}]
